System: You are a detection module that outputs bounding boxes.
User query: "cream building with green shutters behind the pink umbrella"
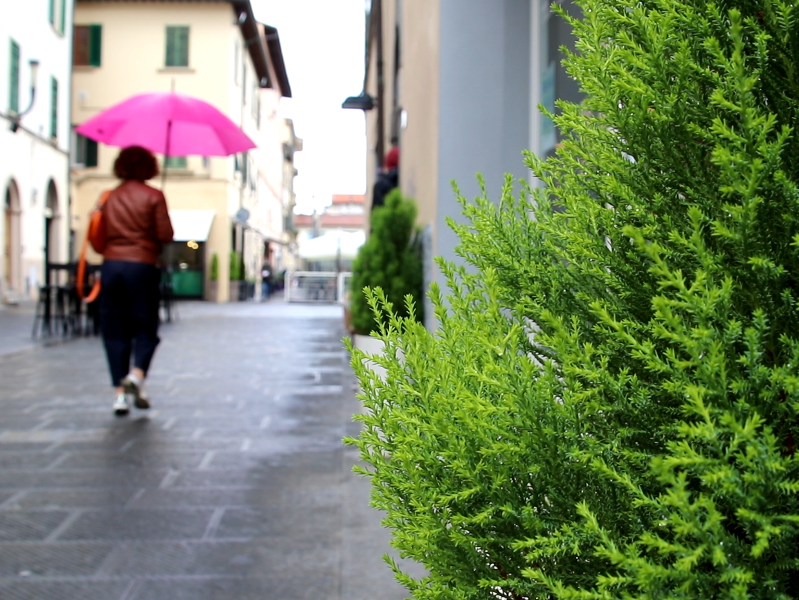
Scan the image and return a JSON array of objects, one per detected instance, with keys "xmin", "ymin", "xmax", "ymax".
[{"xmin": 72, "ymin": 0, "xmax": 291, "ymax": 302}]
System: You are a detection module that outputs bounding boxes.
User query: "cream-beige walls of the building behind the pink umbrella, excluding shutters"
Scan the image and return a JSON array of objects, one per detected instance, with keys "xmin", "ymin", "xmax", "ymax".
[{"xmin": 72, "ymin": 2, "xmax": 282, "ymax": 301}]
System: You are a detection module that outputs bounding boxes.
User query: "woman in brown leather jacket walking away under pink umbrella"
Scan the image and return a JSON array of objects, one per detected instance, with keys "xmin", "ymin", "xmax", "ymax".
[{"xmin": 100, "ymin": 146, "xmax": 174, "ymax": 416}]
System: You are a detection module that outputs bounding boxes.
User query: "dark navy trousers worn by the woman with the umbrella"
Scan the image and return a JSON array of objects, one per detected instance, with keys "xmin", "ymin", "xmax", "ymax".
[{"xmin": 100, "ymin": 260, "xmax": 161, "ymax": 387}]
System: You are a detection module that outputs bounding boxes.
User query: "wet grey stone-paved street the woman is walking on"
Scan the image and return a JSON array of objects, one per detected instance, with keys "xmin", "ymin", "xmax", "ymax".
[{"xmin": 0, "ymin": 301, "xmax": 416, "ymax": 600}]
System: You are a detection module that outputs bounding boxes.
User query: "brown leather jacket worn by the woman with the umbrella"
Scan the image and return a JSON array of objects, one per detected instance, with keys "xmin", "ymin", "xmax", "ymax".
[{"xmin": 103, "ymin": 180, "xmax": 174, "ymax": 265}]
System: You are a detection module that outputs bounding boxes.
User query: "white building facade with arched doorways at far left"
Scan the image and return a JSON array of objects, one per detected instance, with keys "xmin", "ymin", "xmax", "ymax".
[{"xmin": 0, "ymin": 0, "xmax": 73, "ymax": 302}]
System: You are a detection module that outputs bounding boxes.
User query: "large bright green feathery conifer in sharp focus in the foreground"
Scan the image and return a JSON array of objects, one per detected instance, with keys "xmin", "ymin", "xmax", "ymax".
[{"xmin": 350, "ymin": 0, "xmax": 799, "ymax": 600}]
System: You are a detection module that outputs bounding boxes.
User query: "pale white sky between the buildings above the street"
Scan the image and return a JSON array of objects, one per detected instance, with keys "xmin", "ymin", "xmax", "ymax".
[{"xmin": 251, "ymin": 0, "xmax": 366, "ymax": 213}]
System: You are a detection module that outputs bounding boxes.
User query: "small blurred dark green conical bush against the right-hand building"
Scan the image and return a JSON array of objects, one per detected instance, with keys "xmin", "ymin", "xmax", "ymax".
[{"xmin": 350, "ymin": 189, "xmax": 423, "ymax": 335}]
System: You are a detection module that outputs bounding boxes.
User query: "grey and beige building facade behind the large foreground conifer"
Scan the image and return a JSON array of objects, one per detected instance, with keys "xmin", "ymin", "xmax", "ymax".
[{"xmin": 364, "ymin": 0, "xmax": 580, "ymax": 327}]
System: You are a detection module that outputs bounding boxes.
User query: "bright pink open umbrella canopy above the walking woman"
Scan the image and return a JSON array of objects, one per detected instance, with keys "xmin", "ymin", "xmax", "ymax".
[{"xmin": 76, "ymin": 92, "xmax": 255, "ymax": 156}]
